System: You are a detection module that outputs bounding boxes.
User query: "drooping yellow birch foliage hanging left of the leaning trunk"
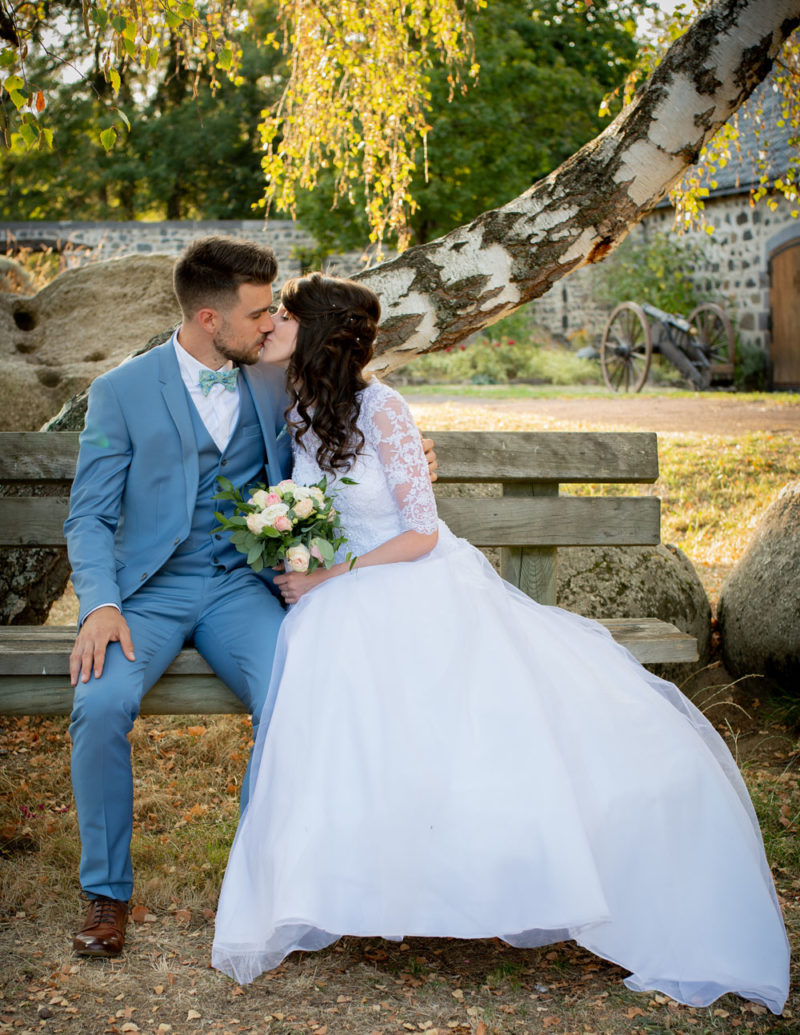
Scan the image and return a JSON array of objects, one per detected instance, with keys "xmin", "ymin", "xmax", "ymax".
[{"xmin": 0, "ymin": 0, "xmax": 485, "ymax": 244}]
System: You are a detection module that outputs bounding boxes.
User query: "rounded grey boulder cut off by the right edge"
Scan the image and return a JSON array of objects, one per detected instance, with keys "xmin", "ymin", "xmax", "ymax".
[{"xmin": 719, "ymin": 481, "xmax": 800, "ymax": 697}]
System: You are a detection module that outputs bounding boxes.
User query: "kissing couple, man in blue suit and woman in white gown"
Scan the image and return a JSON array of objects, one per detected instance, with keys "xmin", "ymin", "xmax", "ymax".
[{"xmin": 66, "ymin": 238, "xmax": 789, "ymax": 1013}]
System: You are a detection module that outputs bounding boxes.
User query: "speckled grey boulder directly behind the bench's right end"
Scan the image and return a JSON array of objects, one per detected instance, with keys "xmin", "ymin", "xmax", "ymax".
[{"xmin": 557, "ymin": 545, "xmax": 711, "ymax": 683}]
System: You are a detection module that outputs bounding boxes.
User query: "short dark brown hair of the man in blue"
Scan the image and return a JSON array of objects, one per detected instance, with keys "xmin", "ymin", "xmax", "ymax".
[{"xmin": 173, "ymin": 237, "xmax": 277, "ymax": 317}]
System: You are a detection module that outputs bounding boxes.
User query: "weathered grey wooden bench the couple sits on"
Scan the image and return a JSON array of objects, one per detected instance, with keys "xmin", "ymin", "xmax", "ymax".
[{"xmin": 0, "ymin": 432, "xmax": 698, "ymax": 715}]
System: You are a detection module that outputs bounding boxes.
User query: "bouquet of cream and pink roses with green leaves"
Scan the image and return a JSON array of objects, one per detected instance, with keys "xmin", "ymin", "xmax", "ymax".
[{"xmin": 212, "ymin": 477, "xmax": 355, "ymax": 572}]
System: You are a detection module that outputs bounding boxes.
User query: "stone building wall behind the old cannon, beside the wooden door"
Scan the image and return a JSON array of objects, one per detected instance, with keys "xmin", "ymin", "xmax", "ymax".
[{"xmin": 534, "ymin": 195, "xmax": 800, "ymax": 349}]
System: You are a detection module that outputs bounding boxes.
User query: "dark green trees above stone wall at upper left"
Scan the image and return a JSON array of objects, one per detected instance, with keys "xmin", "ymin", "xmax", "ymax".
[{"xmin": 0, "ymin": 2, "xmax": 282, "ymax": 219}]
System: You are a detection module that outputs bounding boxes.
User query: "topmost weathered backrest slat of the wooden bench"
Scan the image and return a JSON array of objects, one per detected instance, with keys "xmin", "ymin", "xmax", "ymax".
[{"xmin": 0, "ymin": 432, "xmax": 658, "ymax": 482}]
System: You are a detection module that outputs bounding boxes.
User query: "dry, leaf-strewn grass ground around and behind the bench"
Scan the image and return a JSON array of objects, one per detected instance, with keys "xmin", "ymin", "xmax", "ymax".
[{"xmin": 0, "ymin": 389, "xmax": 800, "ymax": 1035}]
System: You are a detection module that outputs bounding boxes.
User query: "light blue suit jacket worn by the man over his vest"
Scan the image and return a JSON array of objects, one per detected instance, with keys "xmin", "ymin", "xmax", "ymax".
[{"xmin": 64, "ymin": 341, "xmax": 289, "ymax": 622}]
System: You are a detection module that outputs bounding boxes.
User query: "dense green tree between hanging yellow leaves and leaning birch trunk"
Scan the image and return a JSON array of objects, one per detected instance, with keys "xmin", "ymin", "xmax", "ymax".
[{"xmin": 297, "ymin": 0, "xmax": 652, "ymax": 255}]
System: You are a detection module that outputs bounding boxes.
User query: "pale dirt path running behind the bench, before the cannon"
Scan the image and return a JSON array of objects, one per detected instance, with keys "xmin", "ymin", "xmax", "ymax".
[{"xmin": 404, "ymin": 389, "xmax": 800, "ymax": 435}]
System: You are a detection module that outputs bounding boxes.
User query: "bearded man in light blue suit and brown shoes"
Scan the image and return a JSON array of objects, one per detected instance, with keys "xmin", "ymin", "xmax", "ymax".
[{"xmin": 64, "ymin": 237, "xmax": 290, "ymax": 956}]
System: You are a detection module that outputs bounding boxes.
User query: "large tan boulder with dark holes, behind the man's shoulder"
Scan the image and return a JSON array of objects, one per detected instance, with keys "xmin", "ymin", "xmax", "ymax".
[{"xmin": 0, "ymin": 255, "xmax": 180, "ymax": 432}]
